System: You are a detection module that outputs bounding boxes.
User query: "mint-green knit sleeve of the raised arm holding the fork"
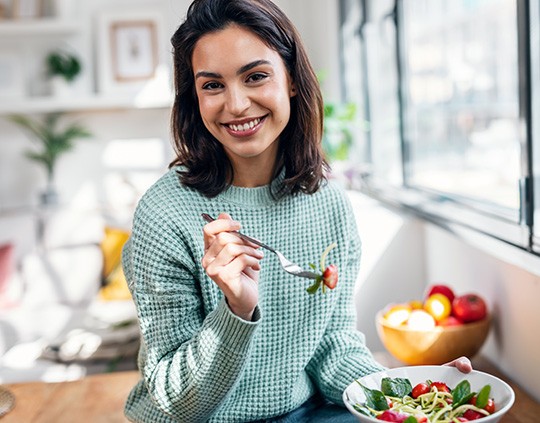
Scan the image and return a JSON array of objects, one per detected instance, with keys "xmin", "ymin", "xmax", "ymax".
[{"xmin": 123, "ymin": 200, "xmax": 260, "ymax": 422}]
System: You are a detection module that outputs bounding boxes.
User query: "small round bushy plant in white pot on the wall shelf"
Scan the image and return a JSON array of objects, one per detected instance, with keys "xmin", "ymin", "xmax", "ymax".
[{"xmin": 45, "ymin": 49, "xmax": 82, "ymax": 95}]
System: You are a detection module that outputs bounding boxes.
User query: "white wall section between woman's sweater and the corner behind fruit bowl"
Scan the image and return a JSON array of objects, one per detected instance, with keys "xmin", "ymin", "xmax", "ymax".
[{"xmin": 348, "ymin": 191, "xmax": 426, "ymax": 351}]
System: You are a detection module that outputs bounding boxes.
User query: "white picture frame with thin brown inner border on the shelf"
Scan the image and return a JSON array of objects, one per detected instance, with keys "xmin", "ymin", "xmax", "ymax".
[{"xmin": 97, "ymin": 10, "xmax": 170, "ymax": 99}]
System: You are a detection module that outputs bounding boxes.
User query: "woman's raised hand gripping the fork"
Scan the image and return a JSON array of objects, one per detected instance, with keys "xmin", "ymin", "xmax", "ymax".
[{"xmin": 202, "ymin": 213, "xmax": 263, "ymax": 320}]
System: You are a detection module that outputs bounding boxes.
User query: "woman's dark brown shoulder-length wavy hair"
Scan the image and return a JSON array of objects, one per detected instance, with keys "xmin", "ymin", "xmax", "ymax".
[{"xmin": 169, "ymin": 0, "xmax": 328, "ymax": 197}]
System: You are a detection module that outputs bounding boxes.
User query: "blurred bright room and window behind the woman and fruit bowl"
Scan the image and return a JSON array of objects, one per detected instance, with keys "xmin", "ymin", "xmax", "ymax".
[{"xmin": 0, "ymin": 0, "xmax": 540, "ymax": 408}]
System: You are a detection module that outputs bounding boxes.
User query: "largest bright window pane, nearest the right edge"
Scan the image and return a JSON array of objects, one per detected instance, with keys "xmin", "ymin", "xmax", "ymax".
[{"xmin": 402, "ymin": 0, "xmax": 521, "ymax": 216}]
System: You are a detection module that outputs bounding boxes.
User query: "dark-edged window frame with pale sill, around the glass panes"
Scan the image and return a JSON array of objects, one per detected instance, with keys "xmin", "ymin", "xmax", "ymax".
[{"xmin": 341, "ymin": 0, "xmax": 540, "ymax": 254}]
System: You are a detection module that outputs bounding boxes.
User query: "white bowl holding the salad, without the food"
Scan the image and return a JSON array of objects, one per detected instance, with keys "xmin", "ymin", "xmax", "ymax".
[{"xmin": 343, "ymin": 366, "xmax": 515, "ymax": 423}]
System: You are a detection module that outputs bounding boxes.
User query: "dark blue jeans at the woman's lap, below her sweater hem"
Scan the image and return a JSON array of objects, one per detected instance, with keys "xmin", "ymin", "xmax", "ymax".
[{"xmin": 257, "ymin": 395, "xmax": 358, "ymax": 423}]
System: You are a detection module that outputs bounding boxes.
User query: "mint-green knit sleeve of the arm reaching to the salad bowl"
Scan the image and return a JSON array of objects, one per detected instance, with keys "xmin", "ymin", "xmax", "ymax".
[{"xmin": 307, "ymin": 195, "xmax": 385, "ymax": 405}]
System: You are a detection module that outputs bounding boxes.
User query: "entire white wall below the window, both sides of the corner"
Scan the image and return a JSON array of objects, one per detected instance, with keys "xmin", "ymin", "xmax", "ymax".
[{"xmin": 350, "ymin": 193, "xmax": 540, "ymax": 401}]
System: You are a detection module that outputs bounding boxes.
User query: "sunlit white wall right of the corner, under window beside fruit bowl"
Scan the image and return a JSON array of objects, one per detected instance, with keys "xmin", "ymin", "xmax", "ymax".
[{"xmin": 423, "ymin": 224, "xmax": 540, "ymax": 401}]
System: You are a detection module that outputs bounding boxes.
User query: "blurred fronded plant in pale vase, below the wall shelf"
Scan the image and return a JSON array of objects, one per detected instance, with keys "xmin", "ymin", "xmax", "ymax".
[{"xmin": 9, "ymin": 113, "xmax": 91, "ymax": 205}]
